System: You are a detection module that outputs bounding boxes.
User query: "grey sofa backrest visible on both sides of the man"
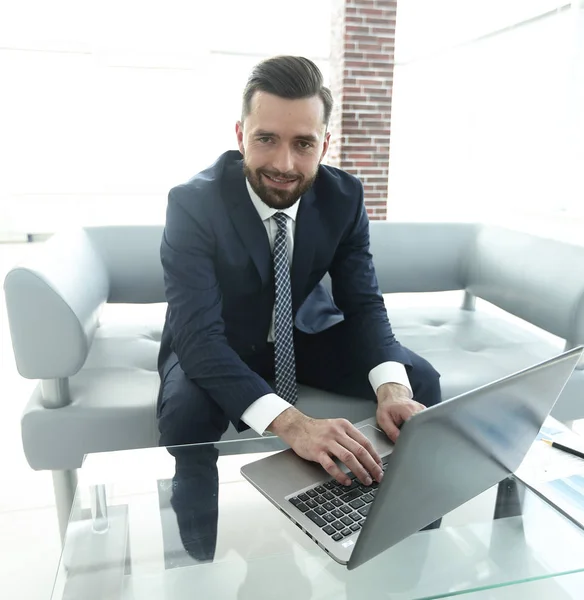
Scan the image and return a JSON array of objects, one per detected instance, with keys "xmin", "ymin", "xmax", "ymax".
[{"xmin": 85, "ymin": 221, "xmax": 477, "ymax": 304}]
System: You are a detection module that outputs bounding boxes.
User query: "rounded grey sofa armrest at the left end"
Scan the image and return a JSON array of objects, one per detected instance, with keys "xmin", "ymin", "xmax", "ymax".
[{"xmin": 4, "ymin": 230, "xmax": 109, "ymax": 379}]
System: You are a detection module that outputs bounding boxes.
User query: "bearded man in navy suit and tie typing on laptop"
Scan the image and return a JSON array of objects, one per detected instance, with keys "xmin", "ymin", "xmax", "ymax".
[{"xmin": 158, "ymin": 56, "xmax": 440, "ymax": 485}]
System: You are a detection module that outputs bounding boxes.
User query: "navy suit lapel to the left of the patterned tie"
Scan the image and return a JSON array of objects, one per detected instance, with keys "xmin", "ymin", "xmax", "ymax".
[{"xmin": 222, "ymin": 160, "xmax": 272, "ymax": 284}]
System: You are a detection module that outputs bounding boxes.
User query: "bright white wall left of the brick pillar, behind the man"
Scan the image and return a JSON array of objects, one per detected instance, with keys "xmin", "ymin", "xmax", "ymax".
[{"xmin": 0, "ymin": 0, "xmax": 330, "ymax": 237}]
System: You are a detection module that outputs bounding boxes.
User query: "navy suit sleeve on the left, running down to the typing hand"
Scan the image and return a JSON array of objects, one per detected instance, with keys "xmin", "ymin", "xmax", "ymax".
[{"xmin": 160, "ymin": 187, "xmax": 273, "ymax": 430}]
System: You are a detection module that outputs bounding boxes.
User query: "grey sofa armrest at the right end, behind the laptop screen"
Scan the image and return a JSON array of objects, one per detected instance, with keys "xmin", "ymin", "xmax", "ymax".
[{"xmin": 467, "ymin": 226, "xmax": 584, "ymax": 346}]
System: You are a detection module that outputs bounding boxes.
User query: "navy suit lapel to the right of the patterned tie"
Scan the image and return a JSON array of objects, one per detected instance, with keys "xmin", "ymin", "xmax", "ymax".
[{"xmin": 291, "ymin": 187, "xmax": 320, "ymax": 312}]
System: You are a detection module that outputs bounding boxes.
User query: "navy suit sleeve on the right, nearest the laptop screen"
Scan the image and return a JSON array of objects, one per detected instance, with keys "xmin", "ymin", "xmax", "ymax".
[{"xmin": 329, "ymin": 182, "xmax": 411, "ymax": 372}]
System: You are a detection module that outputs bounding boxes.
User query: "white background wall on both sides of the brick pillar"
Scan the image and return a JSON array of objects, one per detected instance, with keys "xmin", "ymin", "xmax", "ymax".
[{"xmin": 0, "ymin": 0, "xmax": 584, "ymax": 238}]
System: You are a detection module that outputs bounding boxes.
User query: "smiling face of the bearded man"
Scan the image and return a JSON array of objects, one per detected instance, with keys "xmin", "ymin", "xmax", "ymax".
[{"xmin": 235, "ymin": 92, "xmax": 330, "ymax": 210}]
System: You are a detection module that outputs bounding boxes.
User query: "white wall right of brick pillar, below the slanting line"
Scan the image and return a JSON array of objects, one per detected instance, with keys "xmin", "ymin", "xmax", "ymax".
[{"xmin": 388, "ymin": 9, "xmax": 584, "ymax": 221}]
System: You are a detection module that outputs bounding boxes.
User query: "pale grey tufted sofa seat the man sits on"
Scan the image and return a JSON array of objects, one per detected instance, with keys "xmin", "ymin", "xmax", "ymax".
[{"xmin": 22, "ymin": 304, "xmax": 584, "ymax": 469}]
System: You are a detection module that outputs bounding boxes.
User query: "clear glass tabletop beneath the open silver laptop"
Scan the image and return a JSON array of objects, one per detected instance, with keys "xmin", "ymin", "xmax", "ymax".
[{"xmin": 52, "ymin": 437, "xmax": 584, "ymax": 600}]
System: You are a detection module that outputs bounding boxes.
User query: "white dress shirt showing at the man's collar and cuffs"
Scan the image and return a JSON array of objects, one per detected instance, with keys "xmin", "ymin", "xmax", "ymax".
[{"xmin": 241, "ymin": 180, "xmax": 412, "ymax": 435}]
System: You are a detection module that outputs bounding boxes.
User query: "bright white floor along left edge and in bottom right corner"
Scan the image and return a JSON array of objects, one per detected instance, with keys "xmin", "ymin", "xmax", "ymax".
[{"xmin": 0, "ymin": 244, "xmax": 584, "ymax": 600}]
